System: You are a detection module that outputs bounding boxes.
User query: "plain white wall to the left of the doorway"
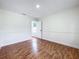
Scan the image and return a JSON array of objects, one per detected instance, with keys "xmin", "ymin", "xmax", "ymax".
[{"xmin": 0, "ymin": 10, "xmax": 33, "ymax": 46}]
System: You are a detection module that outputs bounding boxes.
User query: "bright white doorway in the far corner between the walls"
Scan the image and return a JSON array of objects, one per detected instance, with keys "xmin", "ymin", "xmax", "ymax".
[{"xmin": 32, "ymin": 19, "xmax": 42, "ymax": 38}]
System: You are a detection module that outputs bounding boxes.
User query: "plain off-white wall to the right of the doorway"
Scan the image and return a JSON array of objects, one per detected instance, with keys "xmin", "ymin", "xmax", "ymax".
[{"xmin": 41, "ymin": 8, "xmax": 79, "ymax": 48}]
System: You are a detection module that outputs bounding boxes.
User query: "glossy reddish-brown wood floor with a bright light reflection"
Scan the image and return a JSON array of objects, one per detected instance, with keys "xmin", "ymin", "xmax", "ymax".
[{"xmin": 0, "ymin": 38, "xmax": 79, "ymax": 59}]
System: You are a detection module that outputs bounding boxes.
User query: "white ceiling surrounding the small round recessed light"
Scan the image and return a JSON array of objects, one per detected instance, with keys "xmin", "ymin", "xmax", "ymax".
[{"xmin": 0, "ymin": 0, "xmax": 79, "ymax": 17}]
